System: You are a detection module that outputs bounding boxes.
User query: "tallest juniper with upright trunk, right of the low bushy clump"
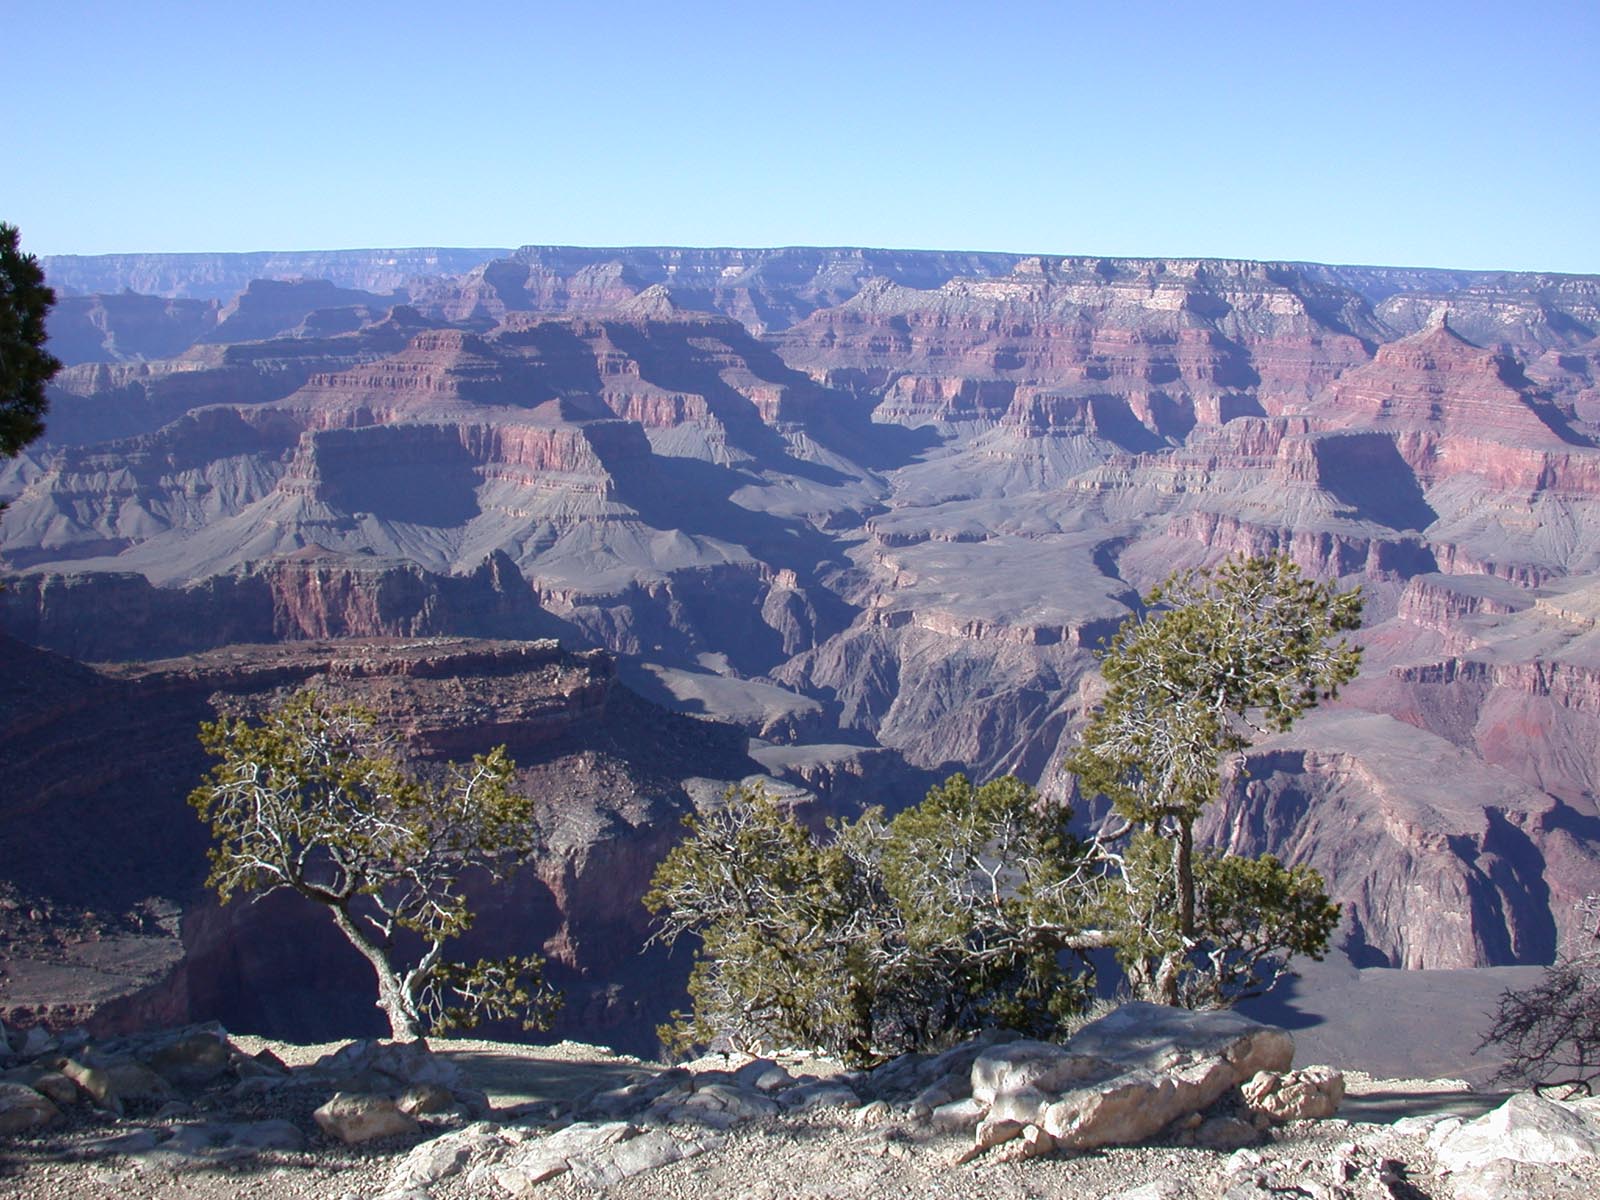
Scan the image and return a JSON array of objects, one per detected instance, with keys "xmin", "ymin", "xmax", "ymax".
[{"xmin": 1066, "ymin": 555, "xmax": 1362, "ymax": 1005}]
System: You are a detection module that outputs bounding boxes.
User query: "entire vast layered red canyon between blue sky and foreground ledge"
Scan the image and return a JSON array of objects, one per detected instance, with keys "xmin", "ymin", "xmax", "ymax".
[{"xmin": 0, "ymin": 246, "xmax": 1600, "ymax": 1046}]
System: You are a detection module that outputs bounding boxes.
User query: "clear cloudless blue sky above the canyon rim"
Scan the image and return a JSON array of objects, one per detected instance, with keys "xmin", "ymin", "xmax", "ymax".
[{"xmin": 0, "ymin": 0, "xmax": 1600, "ymax": 272}]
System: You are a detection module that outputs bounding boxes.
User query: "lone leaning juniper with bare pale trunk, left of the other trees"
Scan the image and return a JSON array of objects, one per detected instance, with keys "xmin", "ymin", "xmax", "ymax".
[{"xmin": 189, "ymin": 691, "xmax": 558, "ymax": 1038}]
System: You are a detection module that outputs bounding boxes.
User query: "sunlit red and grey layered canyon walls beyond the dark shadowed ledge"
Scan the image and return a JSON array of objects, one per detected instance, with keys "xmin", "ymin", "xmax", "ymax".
[{"xmin": 9, "ymin": 246, "xmax": 1600, "ymax": 1036}]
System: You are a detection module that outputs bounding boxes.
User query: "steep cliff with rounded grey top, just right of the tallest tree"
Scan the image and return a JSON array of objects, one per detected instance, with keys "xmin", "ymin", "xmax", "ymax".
[{"xmin": 1205, "ymin": 712, "xmax": 1600, "ymax": 968}]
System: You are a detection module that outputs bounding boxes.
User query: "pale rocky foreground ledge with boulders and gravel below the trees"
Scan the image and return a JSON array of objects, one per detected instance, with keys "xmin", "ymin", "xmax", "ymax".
[{"xmin": 0, "ymin": 1005, "xmax": 1600, "ymax": 1200}]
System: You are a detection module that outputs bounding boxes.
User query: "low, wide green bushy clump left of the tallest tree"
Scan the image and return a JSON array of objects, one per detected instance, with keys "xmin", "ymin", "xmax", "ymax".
[{"xmin": 645, "ymin": 776, "xmax": 1086, "ymax": 1064}]
